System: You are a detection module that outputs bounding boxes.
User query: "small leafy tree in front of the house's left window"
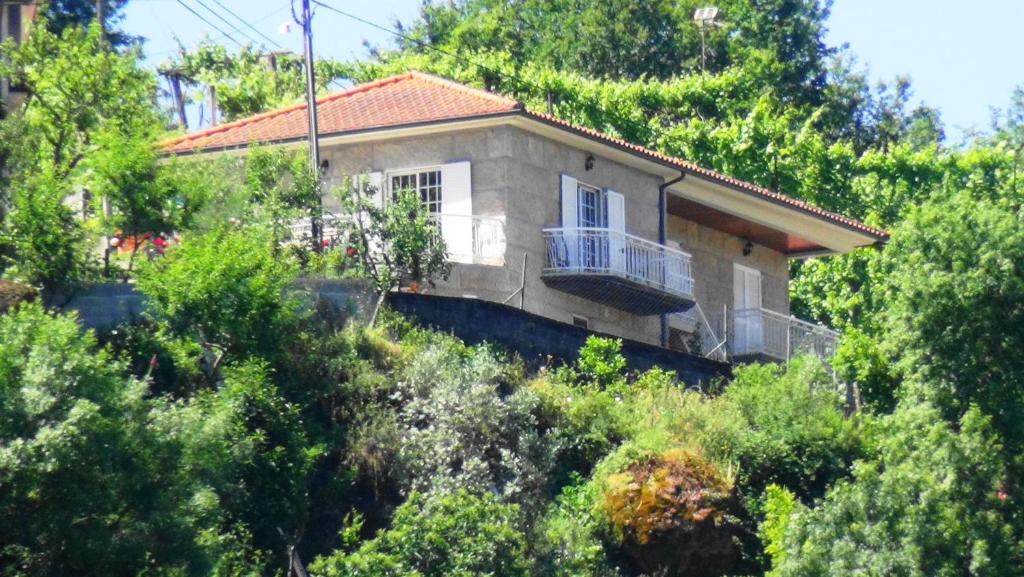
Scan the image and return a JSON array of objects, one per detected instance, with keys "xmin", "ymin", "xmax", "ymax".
[{"xmin": 340, "ymin": 174, "xmax": 449, "ymax": 324}]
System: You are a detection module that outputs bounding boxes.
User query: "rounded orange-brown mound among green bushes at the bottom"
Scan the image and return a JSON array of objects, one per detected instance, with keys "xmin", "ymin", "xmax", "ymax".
[{"xmin": 602, "ymin": 449, "xmax": 739, "ymax": 577}]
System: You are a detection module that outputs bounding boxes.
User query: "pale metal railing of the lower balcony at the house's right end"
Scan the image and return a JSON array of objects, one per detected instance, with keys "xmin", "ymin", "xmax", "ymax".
[{"xmin": 729, "ymin": 308, "xmax": 839, "ymax": 361}]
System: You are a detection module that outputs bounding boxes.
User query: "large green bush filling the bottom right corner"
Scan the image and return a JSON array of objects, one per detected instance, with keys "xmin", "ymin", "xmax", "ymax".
[{"xmin": 772, "ymin": 403, "xmax": 1022, "ymax": 577}]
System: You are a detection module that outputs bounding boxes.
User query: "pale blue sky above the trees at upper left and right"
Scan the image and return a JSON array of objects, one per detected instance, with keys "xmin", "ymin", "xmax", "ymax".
[{"xmin": 124, "ymin": 0, "xmax": 1024, "ymax": 140}]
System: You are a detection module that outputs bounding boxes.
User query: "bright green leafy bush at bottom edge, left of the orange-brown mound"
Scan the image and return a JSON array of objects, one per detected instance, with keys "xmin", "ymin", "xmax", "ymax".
[{"xmin": 310, "ymin": 491, "xmax": 528, "ymax": 577}]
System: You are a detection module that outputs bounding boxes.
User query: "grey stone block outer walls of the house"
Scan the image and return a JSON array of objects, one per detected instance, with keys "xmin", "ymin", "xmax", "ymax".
[{"xmin": 322, "ymin": 126, "xmax": 788, "ymax": 344}]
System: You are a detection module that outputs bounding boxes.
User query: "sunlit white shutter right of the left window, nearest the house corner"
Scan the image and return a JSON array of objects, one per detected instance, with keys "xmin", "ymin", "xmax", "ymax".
[{"xmin": 441, "ymin": 161, "xmax": 474, "ymax": 263}]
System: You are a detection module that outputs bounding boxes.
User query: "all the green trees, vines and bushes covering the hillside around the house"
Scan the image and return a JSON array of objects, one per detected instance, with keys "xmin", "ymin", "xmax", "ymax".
[{"xmin": 0, "ymin": 0, "xmax": 1024, "ymax": 577}]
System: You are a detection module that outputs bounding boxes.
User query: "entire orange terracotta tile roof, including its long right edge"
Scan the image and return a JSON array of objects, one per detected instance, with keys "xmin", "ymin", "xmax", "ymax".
[{"xmin": 160, "ymin": 72, "xmax": 889, "ymax": 241}]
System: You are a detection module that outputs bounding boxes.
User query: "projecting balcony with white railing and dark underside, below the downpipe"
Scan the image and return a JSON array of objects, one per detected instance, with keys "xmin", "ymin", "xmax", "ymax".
[{"xmin": 541, "ymin": 228, "xmax": 694, "ymax": 316}]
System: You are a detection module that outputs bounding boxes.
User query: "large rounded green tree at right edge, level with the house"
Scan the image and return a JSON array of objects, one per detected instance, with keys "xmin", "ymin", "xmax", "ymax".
[{"xmin": 887, "ymin": 194, "xmax": 1024, "ymax": 448}]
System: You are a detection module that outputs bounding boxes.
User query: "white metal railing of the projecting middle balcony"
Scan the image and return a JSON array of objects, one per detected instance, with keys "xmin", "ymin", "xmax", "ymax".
[{"xmin": 543, "ymin": 228, "xmax": 693, "ymax": 298}]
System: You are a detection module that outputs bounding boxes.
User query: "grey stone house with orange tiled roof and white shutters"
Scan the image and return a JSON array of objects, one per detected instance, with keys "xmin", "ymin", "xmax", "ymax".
[{"xmin": 163, "ymin": 72, "xmax": 888, "ymax": 360}]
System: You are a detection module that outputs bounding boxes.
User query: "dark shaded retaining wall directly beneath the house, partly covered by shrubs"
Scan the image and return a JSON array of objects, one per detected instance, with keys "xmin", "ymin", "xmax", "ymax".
[{"xmin": 389, "ymin": 293, "xmax": 731, "ymax": 390}]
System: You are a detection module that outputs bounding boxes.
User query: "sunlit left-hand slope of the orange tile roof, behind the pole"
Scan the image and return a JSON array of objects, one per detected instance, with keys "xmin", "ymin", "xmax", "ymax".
[{"xmin": 160, "ymin": 72, "xmax": 522, "ymax": 154}]
